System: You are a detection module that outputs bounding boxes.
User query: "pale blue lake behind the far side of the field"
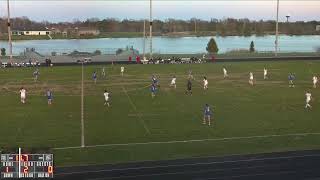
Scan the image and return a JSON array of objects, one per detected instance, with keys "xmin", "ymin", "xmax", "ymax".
[{"xmin": 0, "ymin": 35, "xmax": 320, "ymax": 55}]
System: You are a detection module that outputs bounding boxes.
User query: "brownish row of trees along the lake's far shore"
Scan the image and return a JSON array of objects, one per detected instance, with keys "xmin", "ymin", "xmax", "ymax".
[{"xmin": 0, "ymin": 17, "xmax": 320, "ymax": 36}]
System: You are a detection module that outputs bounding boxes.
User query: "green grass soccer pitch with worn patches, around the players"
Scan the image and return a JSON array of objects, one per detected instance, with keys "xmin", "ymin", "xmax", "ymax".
[{"xmin": 0, "ymin": 61, "xmax": 320, "ymax": 166}]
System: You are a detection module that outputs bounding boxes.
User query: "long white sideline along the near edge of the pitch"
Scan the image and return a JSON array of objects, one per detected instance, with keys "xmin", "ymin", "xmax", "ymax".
[{"xmin": 52, "ymin": 132, "xmax": 320, "ymax": 150}]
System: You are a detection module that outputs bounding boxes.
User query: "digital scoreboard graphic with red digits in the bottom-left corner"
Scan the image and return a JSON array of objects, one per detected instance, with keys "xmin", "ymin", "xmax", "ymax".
[{"xmin": 0, "ymin": 153, "xmax": 54, "ymax": 179}]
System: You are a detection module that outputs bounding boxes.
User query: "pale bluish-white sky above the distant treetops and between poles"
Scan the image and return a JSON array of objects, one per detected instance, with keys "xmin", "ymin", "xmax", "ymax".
[{"xmin": 0, "ymin": 0, "xmax": 320, "ymax": 22}]
